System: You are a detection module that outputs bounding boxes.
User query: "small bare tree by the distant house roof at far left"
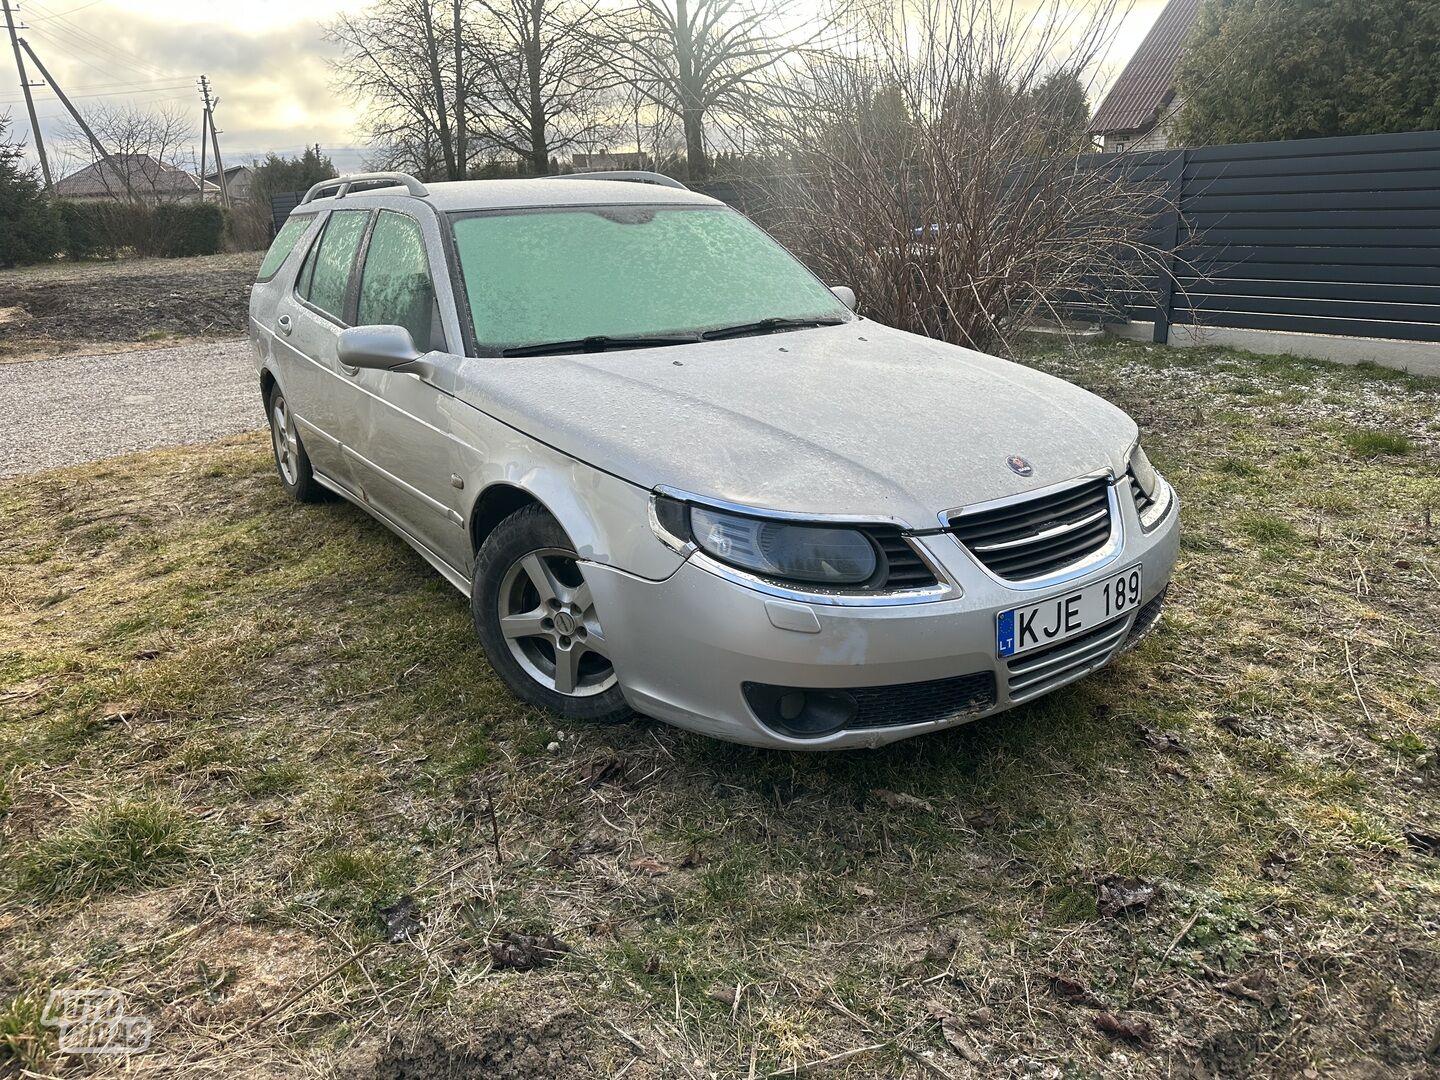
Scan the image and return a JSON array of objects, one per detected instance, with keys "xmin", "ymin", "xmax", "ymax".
[{"xmin": 60, "ymin": 105, "xmax": 203, "ymax": 206}]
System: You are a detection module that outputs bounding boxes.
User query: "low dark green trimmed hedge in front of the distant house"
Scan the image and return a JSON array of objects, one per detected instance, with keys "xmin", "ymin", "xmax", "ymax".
[{"xmin": 60, "ymin": 199, "xmax": 225, "ymax": 259}]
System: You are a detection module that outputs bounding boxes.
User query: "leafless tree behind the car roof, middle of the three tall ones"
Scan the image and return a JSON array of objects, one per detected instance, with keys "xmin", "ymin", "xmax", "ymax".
[{"xmin": 469, "ymin": 0, "xmax": 613, "ymax": 176}]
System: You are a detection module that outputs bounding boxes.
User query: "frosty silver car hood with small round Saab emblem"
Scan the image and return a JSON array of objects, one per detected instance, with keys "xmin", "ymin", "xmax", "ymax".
[{"xmin": 455, "ymin": 320, "xmax": 1136, "ymax": 528}]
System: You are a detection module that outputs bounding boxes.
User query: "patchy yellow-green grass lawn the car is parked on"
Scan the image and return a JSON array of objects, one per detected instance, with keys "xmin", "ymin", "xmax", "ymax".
[{"xmin": 0, "ymin": 343, "xmax": 1440, "ymax": 1077}]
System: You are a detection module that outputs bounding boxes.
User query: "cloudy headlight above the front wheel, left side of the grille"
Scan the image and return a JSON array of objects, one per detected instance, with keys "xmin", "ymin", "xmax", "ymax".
[{"xmin": 654, "ymin": 497, "xmax": 880, "ymax": 586}]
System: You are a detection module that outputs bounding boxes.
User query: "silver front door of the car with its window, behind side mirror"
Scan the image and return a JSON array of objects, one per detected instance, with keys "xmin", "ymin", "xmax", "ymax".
[{"xmin": 342, "ymin": 209, "xmax": 469, "ymax": 570}]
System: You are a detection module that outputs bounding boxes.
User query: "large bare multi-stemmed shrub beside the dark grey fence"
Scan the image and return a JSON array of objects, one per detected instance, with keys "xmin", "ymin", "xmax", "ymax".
[{"xmin": 763, "ymin": 0, "xmax": 1162, "ymax": 350}]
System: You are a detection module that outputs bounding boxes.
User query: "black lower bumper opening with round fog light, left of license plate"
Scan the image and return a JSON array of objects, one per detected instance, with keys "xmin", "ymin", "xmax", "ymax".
[{"xmin": 743, "ymin": 671, "xmax": 996, "ymax": 739}]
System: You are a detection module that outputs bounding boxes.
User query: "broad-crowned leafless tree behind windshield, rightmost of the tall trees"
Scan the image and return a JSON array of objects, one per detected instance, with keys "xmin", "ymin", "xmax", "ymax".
[{"xmin": 602, "ymin": 0, "xmax": 835, "ymax": 180}]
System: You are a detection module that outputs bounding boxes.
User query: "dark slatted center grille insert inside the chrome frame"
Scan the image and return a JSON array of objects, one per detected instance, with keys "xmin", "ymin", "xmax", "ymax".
[{"xmin": 950, "ymin": 477, "xmax": 1110, "ymax": 582}]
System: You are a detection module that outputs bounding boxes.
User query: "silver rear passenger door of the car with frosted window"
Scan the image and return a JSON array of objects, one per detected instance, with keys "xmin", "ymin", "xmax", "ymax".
[{"xmin": 276, "ymin": 210, "xmax": 372, "ymax": 488}]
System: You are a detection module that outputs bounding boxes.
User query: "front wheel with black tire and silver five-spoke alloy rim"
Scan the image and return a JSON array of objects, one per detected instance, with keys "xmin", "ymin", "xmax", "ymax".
[{"xmin": 469, "ymin": 505, "xmax": 631, "ymax": 723}]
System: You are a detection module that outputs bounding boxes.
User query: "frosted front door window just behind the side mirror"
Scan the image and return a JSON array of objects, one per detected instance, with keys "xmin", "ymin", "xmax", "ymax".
[{"xmin": 356, "ymin": 210, "xmax": 445, "ymax": 350}]
